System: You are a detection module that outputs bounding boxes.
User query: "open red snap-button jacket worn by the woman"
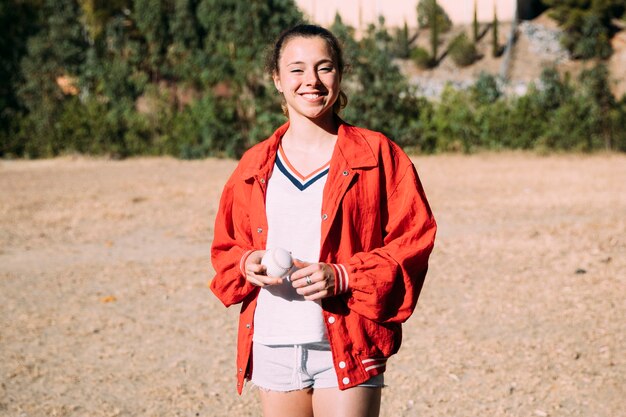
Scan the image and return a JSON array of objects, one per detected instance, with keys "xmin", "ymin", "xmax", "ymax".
[{"xmin": 211, "ymin": 118, "xmax": 436, "ymax": 393}]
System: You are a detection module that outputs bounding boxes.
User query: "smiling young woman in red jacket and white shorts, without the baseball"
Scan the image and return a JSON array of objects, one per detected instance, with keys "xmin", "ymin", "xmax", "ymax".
[{"xmin": 211, "ymin": 25, "xmax": 436, "ymax": 417}]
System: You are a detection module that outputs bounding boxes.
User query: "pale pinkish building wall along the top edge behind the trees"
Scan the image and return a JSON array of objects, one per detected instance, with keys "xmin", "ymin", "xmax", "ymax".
[{"xmin": 296, "ymin": 0, "xmax": 520, "ymax": 28}]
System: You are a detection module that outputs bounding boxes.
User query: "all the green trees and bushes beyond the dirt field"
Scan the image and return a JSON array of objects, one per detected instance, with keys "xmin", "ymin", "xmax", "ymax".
[{"xmin": 0, "ymin": 0, "xmax": 626, "ymax": 158}]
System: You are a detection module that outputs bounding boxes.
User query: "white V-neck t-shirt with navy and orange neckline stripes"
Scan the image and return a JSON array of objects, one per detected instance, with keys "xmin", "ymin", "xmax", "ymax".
[{"xmin": 253, "ymin": 147, "xmax": 330, "ymax": 345}]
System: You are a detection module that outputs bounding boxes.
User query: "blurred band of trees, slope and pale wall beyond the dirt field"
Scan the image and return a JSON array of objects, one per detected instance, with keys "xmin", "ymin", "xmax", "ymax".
[{"xmin": 0, "ymin": 0, "xmax": 626, "ymax": 158}]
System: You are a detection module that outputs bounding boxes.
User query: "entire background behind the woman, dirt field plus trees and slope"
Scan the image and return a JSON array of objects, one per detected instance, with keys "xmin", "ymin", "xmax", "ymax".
[{"xmin": 0, "ymin": 0, "xmax": 626, "ymax": 417}]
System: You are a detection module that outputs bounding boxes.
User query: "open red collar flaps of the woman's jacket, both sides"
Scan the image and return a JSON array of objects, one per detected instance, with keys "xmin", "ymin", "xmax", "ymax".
[{"xmin": 242, "ymin": 117, "xmax": 378, "ymax": 180}]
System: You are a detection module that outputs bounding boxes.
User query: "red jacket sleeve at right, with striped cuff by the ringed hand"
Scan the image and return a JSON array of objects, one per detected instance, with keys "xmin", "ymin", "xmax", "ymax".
[{"xmin": 334, "ymin": 164, "xmax": 437, "ymax": 323}]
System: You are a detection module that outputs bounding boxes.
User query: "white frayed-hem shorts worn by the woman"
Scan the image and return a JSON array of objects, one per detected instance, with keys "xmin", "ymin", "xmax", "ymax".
[{"xmin": 251, "ymin": 341, "xmax": 384, "ymax": 392}]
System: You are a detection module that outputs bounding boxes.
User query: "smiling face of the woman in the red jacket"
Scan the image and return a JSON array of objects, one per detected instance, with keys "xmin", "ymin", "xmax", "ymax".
[{"xmin": 273, "ymin": 37, "xmax": 341, "ymax": 119}]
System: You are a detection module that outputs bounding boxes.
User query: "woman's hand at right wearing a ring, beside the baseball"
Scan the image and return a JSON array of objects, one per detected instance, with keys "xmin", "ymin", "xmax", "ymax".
[{"xmin": 291, "ymin": 259, "xmax": 335, "ymax": 300}]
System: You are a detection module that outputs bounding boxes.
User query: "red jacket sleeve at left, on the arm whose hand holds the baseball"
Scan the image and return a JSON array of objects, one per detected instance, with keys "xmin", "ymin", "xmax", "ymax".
[{"xmin": 210, "ymin": 170, "xmax": 257, "ymax": 307}]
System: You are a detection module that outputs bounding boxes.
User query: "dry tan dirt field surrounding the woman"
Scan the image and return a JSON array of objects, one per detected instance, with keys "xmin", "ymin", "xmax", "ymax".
[{"xmin": 0, "ymin": 154, "xmax": 626, "ymax": 417}]
